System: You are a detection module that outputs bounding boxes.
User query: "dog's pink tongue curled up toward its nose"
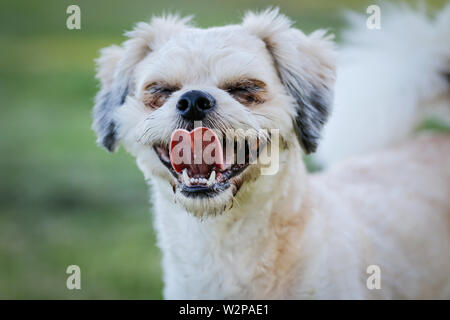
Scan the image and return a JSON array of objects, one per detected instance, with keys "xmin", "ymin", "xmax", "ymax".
[{"xmin": 170, "ymin": 127, "xmax": 223, "ymax": 175}]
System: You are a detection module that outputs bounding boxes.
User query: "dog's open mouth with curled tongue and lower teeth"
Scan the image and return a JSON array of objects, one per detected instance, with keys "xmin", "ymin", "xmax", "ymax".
[{"xmin": 154, "ymin": 127, "xmax": 259, "ymax": 197}]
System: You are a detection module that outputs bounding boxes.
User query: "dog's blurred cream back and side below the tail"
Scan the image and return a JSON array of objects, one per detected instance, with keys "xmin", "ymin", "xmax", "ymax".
[{"xmin": 312, "ymin": 134, "xmax": 450, "ymax": 298}]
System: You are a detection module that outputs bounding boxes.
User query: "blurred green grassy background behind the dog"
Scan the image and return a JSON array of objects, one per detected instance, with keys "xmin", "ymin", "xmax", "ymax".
[{"xmin": 0, "ymin": 0, "xmax": 445, "ymax": 299}]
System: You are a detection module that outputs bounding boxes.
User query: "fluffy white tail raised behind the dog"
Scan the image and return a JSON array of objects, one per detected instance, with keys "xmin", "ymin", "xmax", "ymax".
[{"xmin": 317, "ymin": 3, "xmax": 450, "ymax": 166}]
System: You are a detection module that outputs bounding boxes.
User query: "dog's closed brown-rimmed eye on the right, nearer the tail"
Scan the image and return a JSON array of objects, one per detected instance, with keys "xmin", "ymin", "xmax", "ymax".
[{"xmin": 225, "ymin": 80, "xmax": 267, "ymax": 106}]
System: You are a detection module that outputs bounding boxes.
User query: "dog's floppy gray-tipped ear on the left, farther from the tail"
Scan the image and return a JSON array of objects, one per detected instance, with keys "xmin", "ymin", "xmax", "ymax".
[{"xmin": 92, "ymin": 16, "xmax": 191, "ymax": 152}]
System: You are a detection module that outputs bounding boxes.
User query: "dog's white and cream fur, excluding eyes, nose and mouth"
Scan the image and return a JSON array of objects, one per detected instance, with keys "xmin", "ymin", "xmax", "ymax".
[{"xmin": 92, "ymin": 5, "xmax": 450, "ymax": 299}]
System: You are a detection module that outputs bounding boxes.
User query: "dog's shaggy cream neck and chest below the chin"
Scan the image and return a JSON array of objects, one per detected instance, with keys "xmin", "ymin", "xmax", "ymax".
[{"xmin": 149, "ymin": 150, "xmax": 310, "ymax": 299}]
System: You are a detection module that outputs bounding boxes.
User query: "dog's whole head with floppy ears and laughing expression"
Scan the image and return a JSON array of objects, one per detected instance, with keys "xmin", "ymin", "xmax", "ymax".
[{"xmin": 94, "ymin": 10, "xmax": 334, "ymax": 215}]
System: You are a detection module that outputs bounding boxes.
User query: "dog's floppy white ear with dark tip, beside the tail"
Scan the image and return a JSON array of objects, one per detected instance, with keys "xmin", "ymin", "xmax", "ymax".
[{"xmin": 242, "ymin": 9, "xmax": 335, "ymax": 153}]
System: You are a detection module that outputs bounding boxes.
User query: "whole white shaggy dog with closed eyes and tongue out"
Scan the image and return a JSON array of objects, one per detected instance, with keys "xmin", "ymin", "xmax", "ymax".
[{"xmin": 93, "ymin": 6, "xmax": 450, "ymax": 299}]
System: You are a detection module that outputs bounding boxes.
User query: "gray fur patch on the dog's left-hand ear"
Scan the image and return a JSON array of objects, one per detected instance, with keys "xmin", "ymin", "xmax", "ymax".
[{"xmin": 93, "ymin": 85, "xmax": 128, "ymax": 152}]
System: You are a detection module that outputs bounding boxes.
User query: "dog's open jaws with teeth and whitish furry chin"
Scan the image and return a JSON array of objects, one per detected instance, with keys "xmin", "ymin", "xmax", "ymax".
[{"xmin": 153, "ymin": 127, "xmax": 270, "ymax": 218}]
